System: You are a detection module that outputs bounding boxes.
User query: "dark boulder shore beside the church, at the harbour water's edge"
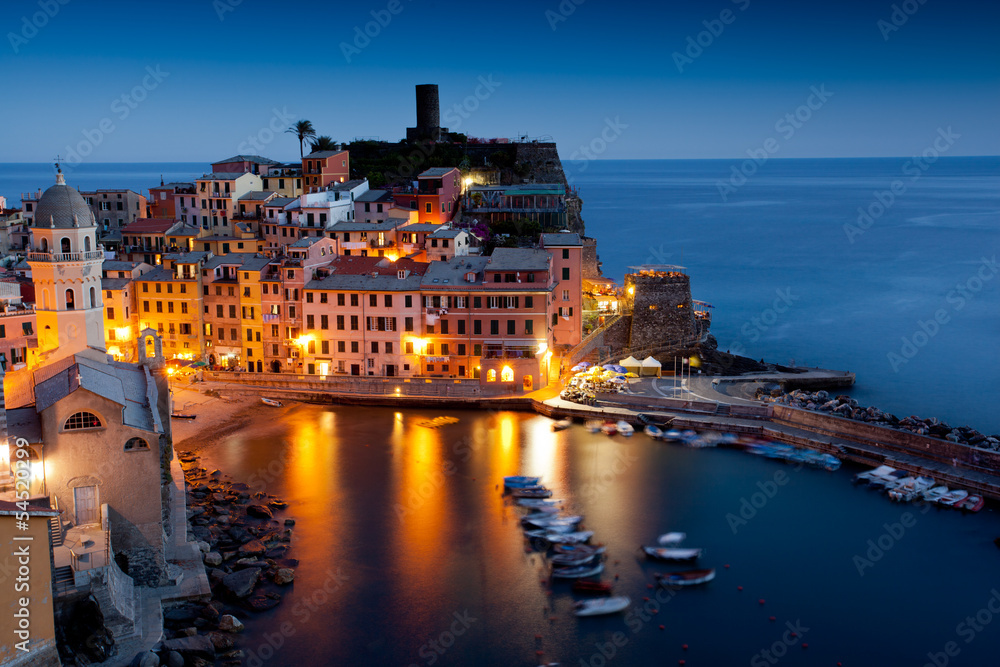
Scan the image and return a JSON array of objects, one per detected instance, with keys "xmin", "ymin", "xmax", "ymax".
[{"xmin": 132, "ymin": 451, "xmax": 298, "ymax": 667}]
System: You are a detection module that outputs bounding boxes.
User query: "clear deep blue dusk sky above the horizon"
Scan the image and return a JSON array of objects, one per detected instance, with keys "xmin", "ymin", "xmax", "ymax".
[{"xmin": 0, "ymin": 0, "xmax": 1000, "ymax": 162}]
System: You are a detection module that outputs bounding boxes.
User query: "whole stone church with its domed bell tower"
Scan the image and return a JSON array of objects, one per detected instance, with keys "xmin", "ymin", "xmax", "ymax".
[{"xmin": 0, "ymin": 171, "xmax": 173, "ymax": 586}]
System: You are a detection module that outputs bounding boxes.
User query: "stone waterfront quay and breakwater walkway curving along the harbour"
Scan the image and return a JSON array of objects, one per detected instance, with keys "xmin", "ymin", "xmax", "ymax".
[{"xmin": 173, "ymin": 369, "xmax": 1000, "ymax": 500}]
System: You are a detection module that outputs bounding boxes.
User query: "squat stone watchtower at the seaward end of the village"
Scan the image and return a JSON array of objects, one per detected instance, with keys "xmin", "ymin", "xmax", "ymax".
[{"xmin": 624, "ymin": 264, "xmax": 698, "ymax": 351}]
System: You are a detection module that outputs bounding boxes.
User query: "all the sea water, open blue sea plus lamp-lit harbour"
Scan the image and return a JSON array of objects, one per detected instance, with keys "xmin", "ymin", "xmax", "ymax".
[{"xmin": 0, "ymin": 158, "xmax": 1000, "ymax": 667}]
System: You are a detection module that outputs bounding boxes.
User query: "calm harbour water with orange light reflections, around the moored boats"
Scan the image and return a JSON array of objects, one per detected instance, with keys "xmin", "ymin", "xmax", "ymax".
[{"xmin": 193, "ymin": 406, "xmax": 1000, "ymax": 667}]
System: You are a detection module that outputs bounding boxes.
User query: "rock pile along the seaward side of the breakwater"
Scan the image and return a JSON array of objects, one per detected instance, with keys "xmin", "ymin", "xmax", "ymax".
[{"xmin": 755, "ymin": 388, "xmax": 1000, "ymax": 452}]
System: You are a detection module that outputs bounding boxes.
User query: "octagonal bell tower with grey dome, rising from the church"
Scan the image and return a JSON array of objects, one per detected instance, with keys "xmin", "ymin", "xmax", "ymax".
[{"xmin": 28, "ymin": 165, "xmax": 107, "ymax": 367}]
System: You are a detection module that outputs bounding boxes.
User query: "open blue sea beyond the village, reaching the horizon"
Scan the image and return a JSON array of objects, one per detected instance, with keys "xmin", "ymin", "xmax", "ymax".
[{"xmin": 0, "ymin": 157, "xmax": 1000, "ymax": 434}]
